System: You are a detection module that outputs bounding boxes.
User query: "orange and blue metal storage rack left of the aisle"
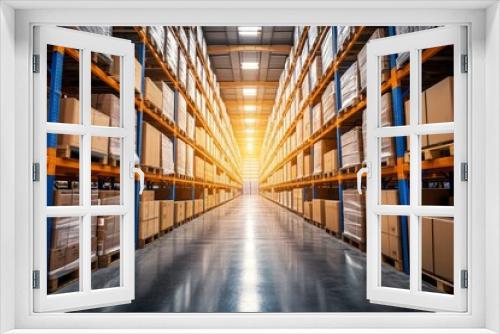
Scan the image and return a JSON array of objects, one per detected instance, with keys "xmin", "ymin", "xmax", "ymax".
[{"xmin": 47, "ymin": 27, "xmax": 242, "ymax": 249}]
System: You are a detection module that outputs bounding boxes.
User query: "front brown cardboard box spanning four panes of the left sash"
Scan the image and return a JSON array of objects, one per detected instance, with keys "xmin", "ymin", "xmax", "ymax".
[{"xmin": 58, "ymin": 97, "xmax": 110, "ymax": 155}]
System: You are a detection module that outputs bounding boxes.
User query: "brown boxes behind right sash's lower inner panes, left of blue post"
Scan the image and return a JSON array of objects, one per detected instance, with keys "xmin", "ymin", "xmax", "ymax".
[{"xmin": 381, "ymin": 189, "xmax": 401, "ymax": 261}]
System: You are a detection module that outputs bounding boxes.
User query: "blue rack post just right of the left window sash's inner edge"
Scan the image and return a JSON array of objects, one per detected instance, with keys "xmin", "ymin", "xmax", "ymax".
[{"xmin": 134, "ymin": 42, "xmax": 146, "ymax": 247}]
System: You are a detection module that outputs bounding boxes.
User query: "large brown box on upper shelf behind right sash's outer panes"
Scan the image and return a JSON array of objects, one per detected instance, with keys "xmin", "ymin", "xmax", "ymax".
[{"xmin": 425, "ymin": 77, "xmax": 453, "ymax": 145}]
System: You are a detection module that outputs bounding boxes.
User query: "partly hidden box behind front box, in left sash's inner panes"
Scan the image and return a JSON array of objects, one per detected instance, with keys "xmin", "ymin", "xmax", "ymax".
[{"xmin": 92, "ymin": 94, "xmax": 121, "ymax": 160}]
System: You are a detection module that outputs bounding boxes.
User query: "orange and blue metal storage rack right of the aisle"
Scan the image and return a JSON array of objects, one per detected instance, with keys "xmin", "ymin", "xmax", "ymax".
[{"xmin": 259, "ymin": 26, "xmax": 454, "ymax": 273}]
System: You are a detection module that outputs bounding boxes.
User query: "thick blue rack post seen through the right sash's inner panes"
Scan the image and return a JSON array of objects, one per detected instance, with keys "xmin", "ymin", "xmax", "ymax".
[{"xmin": 387, "ymin": 27, "xmax": 410, "ymax": 274}]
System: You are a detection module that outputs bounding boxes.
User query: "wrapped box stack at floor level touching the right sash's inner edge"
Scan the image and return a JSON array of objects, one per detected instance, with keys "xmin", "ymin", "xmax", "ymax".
[{"xmin": 342, "ymin": 189, "xmax": 366, "ymax": 243}]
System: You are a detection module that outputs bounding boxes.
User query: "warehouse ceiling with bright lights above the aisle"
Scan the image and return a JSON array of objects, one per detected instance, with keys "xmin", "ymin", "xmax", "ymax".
[{"xmin": 203, "ymin": 26, "xmax": 294, "ymax": 162}]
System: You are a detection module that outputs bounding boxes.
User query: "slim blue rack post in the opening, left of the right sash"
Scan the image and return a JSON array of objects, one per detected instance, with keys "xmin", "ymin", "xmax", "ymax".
[{"xmin": 332, "ymin": 26, "xmax": 344, "ymax": 235}]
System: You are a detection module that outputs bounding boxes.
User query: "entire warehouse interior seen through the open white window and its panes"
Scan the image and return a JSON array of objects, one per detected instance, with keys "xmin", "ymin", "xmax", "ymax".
[{"xmin": 46, "ymin": 26, "xmax": 456, "ymax": 312}]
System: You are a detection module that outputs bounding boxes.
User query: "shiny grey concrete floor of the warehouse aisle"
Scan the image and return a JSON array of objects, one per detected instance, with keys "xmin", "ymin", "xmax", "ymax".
[{"xmin": 65, "ymin": 196, "xmax": 418, "ymax": 312}]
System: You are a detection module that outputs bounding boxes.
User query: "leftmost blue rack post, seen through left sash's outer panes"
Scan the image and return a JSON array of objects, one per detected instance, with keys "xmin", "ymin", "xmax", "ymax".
[{"xmin": 47, "ymin": 46, "xmax": 64, "ymax": 256}]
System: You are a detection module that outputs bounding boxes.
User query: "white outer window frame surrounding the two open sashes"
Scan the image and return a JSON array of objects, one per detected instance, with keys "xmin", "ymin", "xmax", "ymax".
[{"xmin": 0, "ymin": 0, "xmax": 500, "ymax": 333}]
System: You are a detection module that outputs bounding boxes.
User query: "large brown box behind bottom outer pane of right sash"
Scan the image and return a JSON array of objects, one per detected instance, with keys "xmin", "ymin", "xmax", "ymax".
[{"xmin": 432, "ymin": 218, "xmax": 454, "ymax": 282}]
